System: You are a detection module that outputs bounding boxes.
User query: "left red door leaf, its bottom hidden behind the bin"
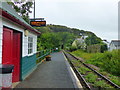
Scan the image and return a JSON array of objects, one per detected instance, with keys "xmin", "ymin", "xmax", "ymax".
[{"xmin": 2, "ymin": 28, "xmax": 13, "ymax": 64}]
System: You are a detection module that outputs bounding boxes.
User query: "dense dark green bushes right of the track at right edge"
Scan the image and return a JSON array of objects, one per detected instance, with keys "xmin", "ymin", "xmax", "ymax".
[{"xmin": 89, "ymin": 50, "xmax": 120, "ymax": 75}]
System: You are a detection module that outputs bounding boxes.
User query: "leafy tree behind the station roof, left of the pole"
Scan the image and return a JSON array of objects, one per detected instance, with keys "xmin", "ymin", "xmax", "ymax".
[{"xmin": 7, "ymin": 0, "xmax": 33, "ymax": 23}]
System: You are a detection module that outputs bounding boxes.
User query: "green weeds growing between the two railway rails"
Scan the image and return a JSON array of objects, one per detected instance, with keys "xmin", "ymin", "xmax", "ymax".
[{"xmin": 71, "ymin": 60, "xmax": 113, "ymax": 88}]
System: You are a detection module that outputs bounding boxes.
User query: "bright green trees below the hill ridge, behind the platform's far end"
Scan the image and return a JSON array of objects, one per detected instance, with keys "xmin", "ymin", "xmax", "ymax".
[{"xmin": 38, "ymin": 32, "xmax": 74, "ymax": 50}]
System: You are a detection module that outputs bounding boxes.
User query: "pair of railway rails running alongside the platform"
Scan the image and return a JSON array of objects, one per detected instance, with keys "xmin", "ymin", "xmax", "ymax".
[{"xmin": 63, "ymin": 51, "xmax": 120, "ymax": 90}]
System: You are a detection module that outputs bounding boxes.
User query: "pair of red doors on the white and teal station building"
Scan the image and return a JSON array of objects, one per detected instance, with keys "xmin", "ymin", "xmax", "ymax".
[{"xmin": 2, "ymin": 28, "xmax": 20, "ymax": 82}]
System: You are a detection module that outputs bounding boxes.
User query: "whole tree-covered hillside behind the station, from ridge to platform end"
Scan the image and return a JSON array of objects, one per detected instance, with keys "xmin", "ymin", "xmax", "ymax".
[{"xmin": 35, "ymin": 25, "xmax": 102, "ymax": 50}]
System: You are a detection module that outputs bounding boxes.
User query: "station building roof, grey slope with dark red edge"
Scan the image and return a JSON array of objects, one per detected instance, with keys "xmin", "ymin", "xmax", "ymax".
[{"xmin": 0, "ymin": 2, "xmax": 40, "ymax": 34}]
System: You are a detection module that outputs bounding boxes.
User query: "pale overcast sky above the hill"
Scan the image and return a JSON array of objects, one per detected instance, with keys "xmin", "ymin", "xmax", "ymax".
[{"xmin": 30, "ymin": 0, "xmax": 119, "ymax": 41}]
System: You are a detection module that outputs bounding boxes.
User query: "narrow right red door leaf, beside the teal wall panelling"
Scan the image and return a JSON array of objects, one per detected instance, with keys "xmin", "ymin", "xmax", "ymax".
[{"xmin": 13, "ymin": 32, "xmax": 21, "ymax": 82}]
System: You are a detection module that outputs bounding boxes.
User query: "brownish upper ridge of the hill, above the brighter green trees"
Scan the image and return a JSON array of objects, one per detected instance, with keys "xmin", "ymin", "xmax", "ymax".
[{"xmin": 36, "ymin": 24, "xmax": 101, "ymax": 37}]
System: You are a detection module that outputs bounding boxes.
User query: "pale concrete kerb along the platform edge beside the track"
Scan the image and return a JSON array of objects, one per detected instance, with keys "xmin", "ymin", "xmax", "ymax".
[{"xmin": 62, "ymin": 52, "xmax": 83, "ymax": 88}]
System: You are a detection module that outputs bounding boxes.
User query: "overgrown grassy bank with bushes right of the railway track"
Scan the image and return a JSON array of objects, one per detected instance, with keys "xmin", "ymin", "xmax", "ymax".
[{"xmin": 72, "ymin": 50, "xmax": 120, "ymax": 86}]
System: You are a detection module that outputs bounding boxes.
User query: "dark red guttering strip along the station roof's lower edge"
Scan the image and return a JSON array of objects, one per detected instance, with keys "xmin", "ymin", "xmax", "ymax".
[{"xmin": 0, "ymin": 9, "xmax": 41, "ymax": 35}]
